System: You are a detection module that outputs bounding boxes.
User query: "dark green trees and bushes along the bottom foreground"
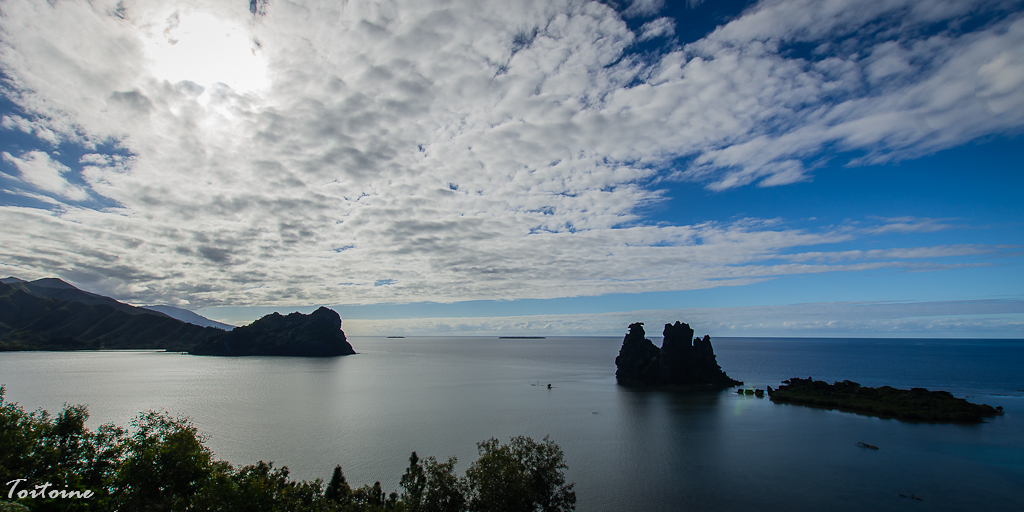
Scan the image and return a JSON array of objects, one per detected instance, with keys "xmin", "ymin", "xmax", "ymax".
[{"xmin": 0, "ymin": 385, "xmax": 575, "ymax": 512}]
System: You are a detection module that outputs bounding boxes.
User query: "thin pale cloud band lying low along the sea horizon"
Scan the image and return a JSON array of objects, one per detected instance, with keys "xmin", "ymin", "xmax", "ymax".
[{"xmin": 344, "ymin": 300, "xmax": 1024, "ymax": 338}]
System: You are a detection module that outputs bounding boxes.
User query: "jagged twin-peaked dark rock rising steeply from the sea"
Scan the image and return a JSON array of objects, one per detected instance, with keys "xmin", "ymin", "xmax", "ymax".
[{"xmin": 615, "ymin": 322, "xmax": 742, "ymax": 387}]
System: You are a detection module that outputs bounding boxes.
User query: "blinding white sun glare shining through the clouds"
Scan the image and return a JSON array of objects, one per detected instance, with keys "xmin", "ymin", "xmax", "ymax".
[{"xmin": 146, "ymin": 11, "xmax": 270, "ymax": 93}]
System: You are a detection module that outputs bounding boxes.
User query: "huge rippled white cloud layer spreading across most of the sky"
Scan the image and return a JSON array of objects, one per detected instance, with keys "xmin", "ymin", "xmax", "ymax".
[{"xmin": 0, "ymin": 0, "xmax": 1024, "ymax": 305}]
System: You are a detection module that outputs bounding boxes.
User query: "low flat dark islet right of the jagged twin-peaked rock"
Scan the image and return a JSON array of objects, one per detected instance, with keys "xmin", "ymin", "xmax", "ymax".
[{"xmin": 768, "ymin": 377, "xmax": 1002, "ymax": 423}]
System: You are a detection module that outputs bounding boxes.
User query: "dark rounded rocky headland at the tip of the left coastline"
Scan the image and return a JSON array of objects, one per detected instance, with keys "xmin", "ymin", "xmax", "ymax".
[{"xmin": 190, "ymin": 306, "xmax": 355, "ymax": 357}]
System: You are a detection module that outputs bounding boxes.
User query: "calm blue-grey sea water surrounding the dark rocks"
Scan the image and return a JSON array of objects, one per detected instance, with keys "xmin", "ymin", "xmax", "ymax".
[{"xmin": 0, "ymin": 337, "xmax": 1024, "ymax": 512}]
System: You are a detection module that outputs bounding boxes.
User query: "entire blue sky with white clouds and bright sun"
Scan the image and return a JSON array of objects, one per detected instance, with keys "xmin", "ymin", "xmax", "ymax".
[{"xmin": 0, "ymin": 0, "xmax": 1024, "ymax": 338}]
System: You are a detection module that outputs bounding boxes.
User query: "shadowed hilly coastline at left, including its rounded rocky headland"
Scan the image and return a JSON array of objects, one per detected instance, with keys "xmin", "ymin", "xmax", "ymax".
[{"xmin": 0, "ymin": 278, "xmax": 355, "ymax": 357}]
